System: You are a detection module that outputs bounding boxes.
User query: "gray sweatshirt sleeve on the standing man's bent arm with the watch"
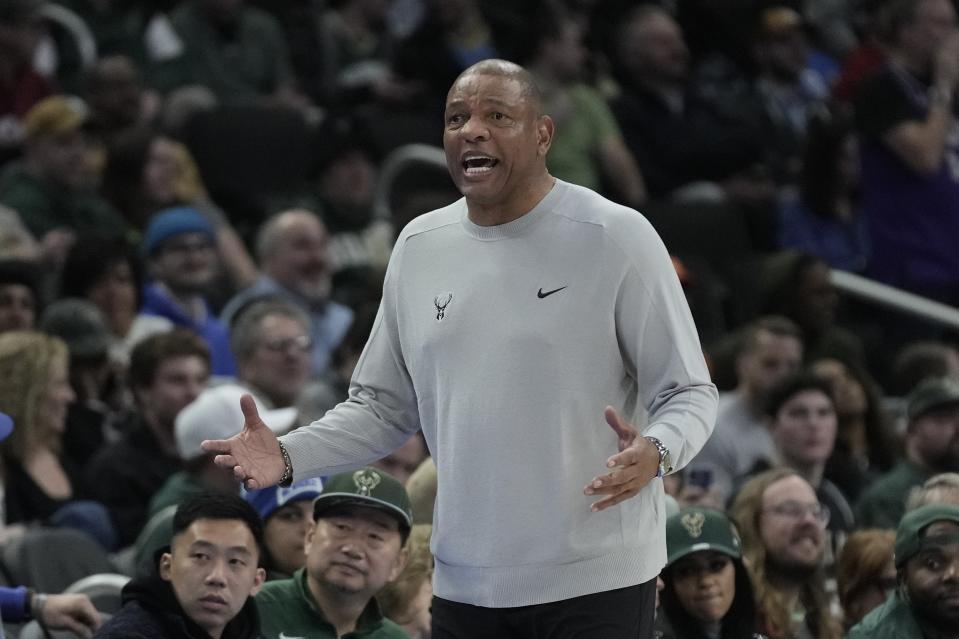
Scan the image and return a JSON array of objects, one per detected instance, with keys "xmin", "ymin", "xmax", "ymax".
[{"xmin": 612, "ymin": 212, "xmax": 718, "ymax": 470}]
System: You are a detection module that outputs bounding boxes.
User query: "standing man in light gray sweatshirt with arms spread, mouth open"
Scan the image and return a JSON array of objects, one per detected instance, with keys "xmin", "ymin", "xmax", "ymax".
[{"xmin": 204, "ymin": 60, "xmax": 716, "ymax": 639}]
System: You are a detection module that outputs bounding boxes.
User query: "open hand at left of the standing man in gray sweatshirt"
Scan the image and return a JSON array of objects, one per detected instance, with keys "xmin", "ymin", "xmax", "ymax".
[{"xmin": 201, "ymin": 395, "xmax": 286, "ymax": 490}]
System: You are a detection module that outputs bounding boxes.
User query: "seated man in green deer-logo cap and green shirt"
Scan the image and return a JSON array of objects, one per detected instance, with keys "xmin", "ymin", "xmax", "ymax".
[{"xmin": 256, "ymin": 468, "xmax": 413, "ymax": 639}]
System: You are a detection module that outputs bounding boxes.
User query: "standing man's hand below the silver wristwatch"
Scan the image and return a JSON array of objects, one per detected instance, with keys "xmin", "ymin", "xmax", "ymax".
[{"xmin": 583, "ymin": 406, "xmax": 659, "ymax": 512}]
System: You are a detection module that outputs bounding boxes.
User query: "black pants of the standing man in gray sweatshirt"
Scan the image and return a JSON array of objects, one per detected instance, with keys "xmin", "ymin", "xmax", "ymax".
[{"xmin": 432, "ymin": 579, "xmax": 656, "ymax": 639}]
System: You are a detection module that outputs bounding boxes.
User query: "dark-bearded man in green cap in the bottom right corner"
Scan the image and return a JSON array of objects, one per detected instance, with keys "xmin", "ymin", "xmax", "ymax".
[{"xmin": 847, "ymin": 504, "xmax": 959, "ymax": 639}]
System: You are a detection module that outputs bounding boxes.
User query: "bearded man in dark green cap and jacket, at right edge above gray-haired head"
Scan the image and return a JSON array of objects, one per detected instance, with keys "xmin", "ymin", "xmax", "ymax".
[{"xmin": 856, "ymin": 377, "xmax": 959, "ymax": 528}]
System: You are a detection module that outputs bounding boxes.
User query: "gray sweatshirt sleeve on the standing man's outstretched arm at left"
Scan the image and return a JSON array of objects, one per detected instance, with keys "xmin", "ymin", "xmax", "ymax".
[{"xmin": 282, "ymin": 237, "xmax": 420, "ymax": 481}]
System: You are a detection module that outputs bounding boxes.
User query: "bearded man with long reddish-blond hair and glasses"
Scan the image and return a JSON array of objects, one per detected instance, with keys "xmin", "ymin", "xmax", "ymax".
[{"xmin": 731, "ymin": 468, "xmax": 841, "ymax": 639}]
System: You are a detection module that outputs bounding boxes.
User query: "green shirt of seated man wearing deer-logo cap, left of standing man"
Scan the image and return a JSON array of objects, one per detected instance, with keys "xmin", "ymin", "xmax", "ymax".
[{"xmin": 256, "ymin": 568, "xmax": 409, "ymax": 639}]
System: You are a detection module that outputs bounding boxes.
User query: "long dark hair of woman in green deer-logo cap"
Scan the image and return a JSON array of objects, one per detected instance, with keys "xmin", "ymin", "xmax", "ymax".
[{"xmin": 661, "ymin": 557, "xmax": 757, "ymax": 639}]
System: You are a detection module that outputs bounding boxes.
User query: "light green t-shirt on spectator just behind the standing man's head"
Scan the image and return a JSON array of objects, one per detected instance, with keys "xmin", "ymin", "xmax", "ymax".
[{"xmin": 546, "ymin": 84, "xmax": 623, "ymax": 191}]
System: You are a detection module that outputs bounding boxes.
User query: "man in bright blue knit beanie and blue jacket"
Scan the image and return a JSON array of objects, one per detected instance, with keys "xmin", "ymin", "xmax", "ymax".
[{"xmin": 140, "ymin": 206, "xmax": 236, "ymax": 375}]
